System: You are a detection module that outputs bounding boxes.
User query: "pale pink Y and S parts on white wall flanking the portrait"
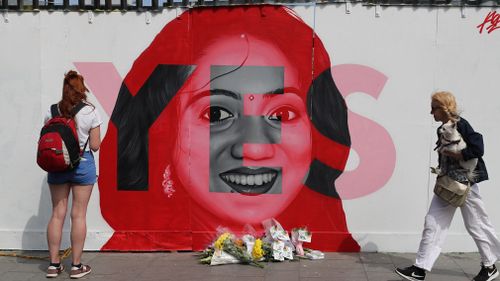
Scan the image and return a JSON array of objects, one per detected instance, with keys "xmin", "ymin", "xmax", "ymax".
[{"xmin": 75, "ymin": 62, "xmax": 396, "ymax": 199}]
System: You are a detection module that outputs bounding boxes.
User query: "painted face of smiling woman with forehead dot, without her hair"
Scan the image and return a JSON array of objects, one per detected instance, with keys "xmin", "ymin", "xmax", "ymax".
[{"xmin": 175, "ymin": 37, "xmax": 311, "ymax": 223}]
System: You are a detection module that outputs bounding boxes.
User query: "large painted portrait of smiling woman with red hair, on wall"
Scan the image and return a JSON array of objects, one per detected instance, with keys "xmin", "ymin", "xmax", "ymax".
[{"xmin": 99, "ymin": 5, "xmax": 359, "ymax": 251}]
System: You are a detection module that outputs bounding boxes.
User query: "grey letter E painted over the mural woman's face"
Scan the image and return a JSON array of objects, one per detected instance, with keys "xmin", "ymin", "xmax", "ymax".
[{"xmin": 210, "ymin": 66, "xmax": 284, "ymax": 195}]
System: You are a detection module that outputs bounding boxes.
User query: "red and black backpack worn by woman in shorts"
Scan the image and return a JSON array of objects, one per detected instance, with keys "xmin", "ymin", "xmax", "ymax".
[{"xmin": 36, "ymin": 102, "xmax": 88, "ymax": 172}]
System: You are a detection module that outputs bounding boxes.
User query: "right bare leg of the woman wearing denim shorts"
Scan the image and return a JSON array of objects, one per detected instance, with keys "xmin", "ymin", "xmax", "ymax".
[{"xmin": 71, "ymin": 185, "xmax": 93, "ymax": 264}]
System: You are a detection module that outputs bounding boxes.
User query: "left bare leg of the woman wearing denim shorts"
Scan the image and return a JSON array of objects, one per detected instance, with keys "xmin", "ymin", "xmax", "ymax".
[{"xmin": 47, "ymin": 184, "xmax": 70, "ymax": 263}]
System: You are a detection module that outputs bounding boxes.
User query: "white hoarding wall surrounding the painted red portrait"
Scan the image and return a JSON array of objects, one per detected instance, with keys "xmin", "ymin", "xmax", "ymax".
[{"xmin": 0, "ymin": 4, "xmax": 500, "ymax": 252}]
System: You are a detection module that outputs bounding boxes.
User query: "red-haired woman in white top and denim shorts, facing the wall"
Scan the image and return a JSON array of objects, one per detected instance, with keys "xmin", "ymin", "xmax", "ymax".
[{"xmin": 44, "ymin": 71, "xmax": 102, "ymax": 278}]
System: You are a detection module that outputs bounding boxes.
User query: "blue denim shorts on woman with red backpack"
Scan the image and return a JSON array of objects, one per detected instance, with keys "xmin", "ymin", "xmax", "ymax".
[{"xmin": 47, "ymin": 151, "xmax": 97, "ymax": 185}]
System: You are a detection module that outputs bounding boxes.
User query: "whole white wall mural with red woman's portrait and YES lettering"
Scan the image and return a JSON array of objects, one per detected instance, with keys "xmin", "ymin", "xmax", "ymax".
[{"xmin": 0, "ymin": 0, "xmax": 500, "ymax": 252}]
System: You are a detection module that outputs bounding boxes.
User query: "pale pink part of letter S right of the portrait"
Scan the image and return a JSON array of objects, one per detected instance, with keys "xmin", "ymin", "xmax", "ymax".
[{"xmin": 332, "ymin": 64, "xmax": 396, "ymax": 199}]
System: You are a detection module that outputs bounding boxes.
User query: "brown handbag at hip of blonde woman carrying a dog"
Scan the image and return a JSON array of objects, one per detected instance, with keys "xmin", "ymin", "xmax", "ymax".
[{"xmin": 434, "ymin": 175, "xmax": 470, "ymax": 207}]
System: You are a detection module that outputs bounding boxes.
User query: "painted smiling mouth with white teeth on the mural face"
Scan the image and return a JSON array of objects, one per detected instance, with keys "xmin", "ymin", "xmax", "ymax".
[{"xmin": 219, "ymin": 167, "xmax": 278, "ymax": 195}]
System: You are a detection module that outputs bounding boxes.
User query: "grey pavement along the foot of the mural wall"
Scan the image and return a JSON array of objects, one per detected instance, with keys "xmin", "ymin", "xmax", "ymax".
[{"xmin": 0, "ymin": 251, "xmax": 488, "ymax": 281}]
